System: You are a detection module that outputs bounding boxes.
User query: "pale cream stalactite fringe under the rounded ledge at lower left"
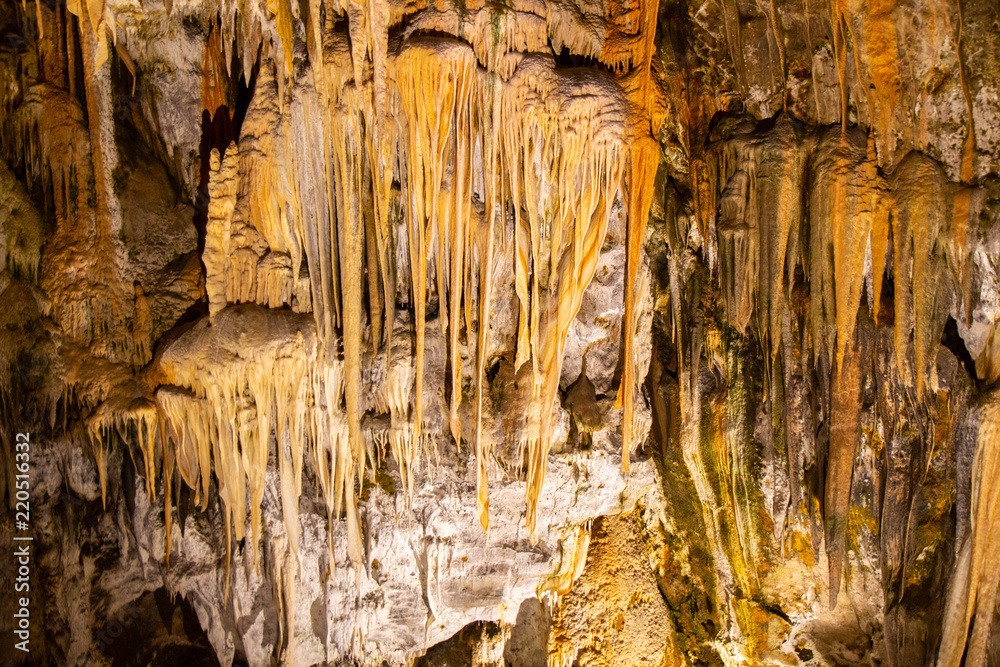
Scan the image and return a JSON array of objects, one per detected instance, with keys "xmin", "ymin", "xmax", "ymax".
[{"xmin": 156, "ymin": 306, "xmax": 356, "ymax": 596}]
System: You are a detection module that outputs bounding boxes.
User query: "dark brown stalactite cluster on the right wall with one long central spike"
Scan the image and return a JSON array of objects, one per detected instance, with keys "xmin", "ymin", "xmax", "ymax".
[{"xmin": 699, "ymin": 115, "xmax": 979, "ymax": 601}]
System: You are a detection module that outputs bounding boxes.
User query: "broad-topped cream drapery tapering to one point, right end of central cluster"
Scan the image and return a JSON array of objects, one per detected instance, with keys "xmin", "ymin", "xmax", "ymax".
[{"xmin": 502, "ymin": 57, "xmax": 624, "ymax": 533}]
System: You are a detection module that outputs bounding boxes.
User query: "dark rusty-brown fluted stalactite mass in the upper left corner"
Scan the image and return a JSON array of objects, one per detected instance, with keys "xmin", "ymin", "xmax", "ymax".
[{"xmin": 0, "ymin": 2, "xmax": 141, "ymax": 364}]
